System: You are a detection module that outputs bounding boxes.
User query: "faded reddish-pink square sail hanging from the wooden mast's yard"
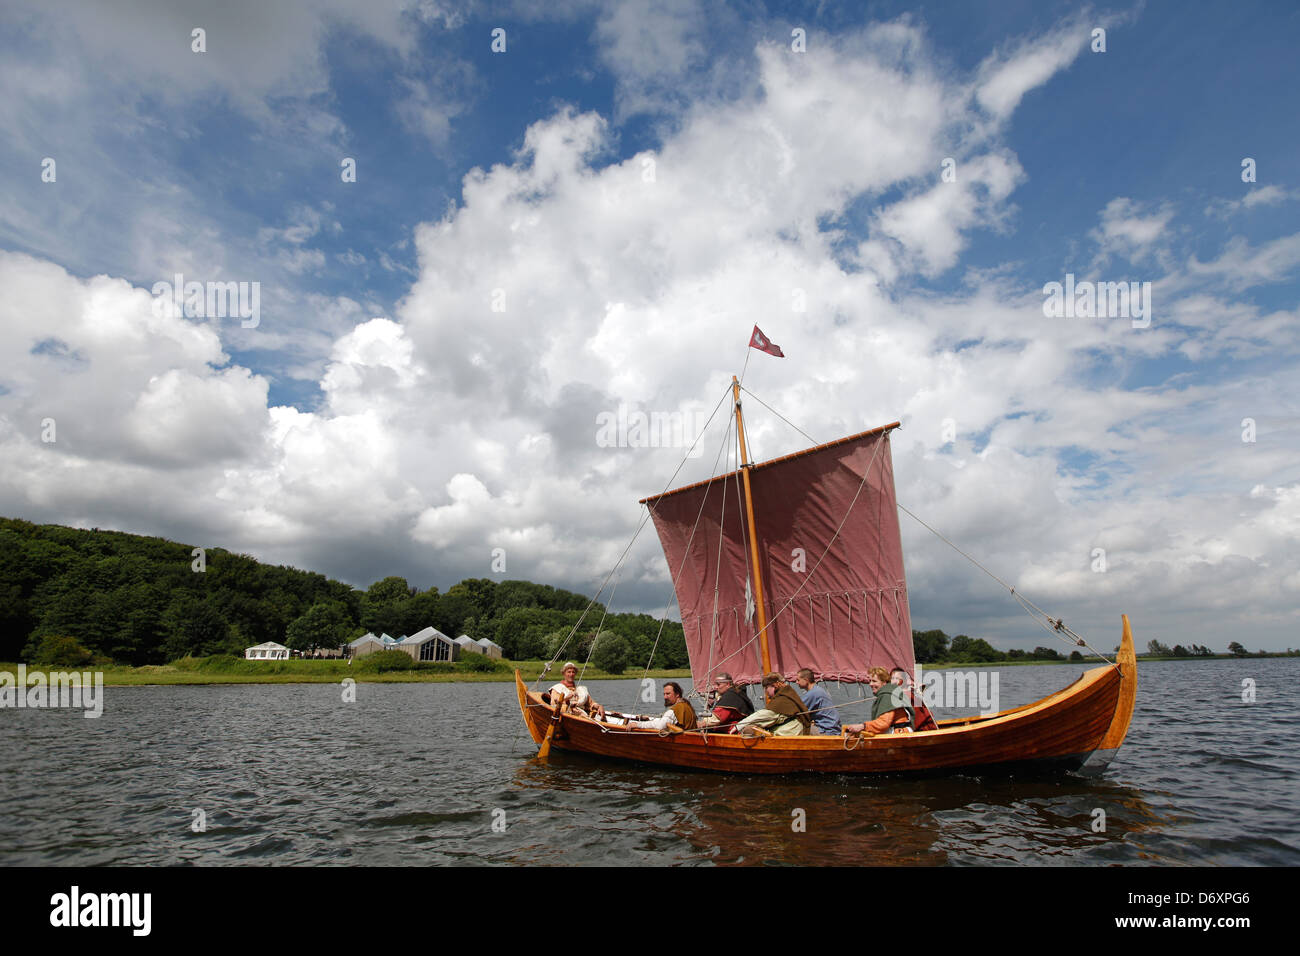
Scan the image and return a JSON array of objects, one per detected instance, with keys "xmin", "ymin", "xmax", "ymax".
[{"xmin": 645, "ymin": 423, "xmax": 915, "ymax": 691}]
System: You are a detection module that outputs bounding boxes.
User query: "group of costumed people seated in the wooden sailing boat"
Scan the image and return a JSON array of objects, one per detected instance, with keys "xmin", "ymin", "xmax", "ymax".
[{"xmin": 542, "ymin": 661, "xmax": 939, "ymax": 737}]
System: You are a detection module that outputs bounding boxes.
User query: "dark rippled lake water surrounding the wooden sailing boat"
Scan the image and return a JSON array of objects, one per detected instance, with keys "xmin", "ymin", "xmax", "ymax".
[{"xmin": 0, "ymin": 658, "xmax": 1300, "ymax": 866}]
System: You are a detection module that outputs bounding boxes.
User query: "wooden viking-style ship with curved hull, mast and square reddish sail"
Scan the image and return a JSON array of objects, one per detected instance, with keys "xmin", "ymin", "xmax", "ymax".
[{"xmin": 515, "ymin": 378, "xmax": 1138, "ymax": 774}]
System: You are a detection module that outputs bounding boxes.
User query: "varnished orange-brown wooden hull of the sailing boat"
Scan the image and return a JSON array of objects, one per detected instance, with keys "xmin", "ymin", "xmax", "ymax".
[{"xmin": 515, "ymin": 615, "xmax": 1138, "ymax": 774}]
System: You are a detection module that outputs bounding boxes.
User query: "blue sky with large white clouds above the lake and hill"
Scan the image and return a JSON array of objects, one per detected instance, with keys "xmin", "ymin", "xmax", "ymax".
[{"xmin": 0, "ymin": 0, "xmax": 1300, "ymax": 646}]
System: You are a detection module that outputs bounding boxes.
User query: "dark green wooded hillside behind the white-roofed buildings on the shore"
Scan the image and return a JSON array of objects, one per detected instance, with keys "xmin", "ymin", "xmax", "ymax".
[{"xmin": 0, "ymin": 518, "xmax": 686, "ymax": 672}]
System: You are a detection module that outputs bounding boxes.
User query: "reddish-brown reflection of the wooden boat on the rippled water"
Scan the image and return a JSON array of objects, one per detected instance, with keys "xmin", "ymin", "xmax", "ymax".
[{"xmin": 515, "ymin": 750, "xmax": 1173, "ymax": 866}]
